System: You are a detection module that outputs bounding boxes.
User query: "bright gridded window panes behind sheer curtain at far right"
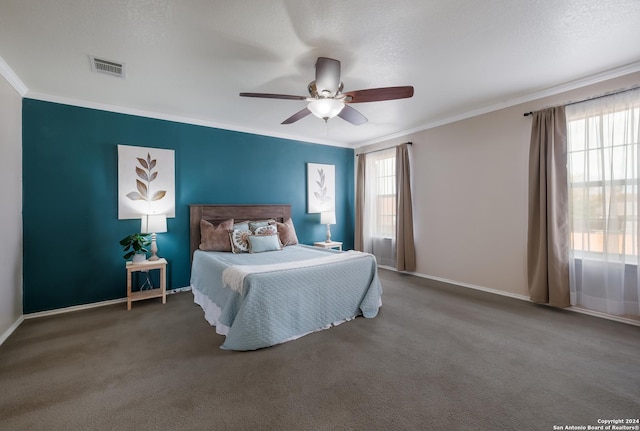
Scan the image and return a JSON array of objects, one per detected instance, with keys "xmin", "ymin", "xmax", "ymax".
[{"xmin": 567, "ymin": 98, "xmax": 640, "ymax": 257}]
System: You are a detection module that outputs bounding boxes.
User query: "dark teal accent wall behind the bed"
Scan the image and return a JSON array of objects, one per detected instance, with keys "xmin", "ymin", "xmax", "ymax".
[{"xmin": 22, "ymin": 99, "xmax": 355, "ymax": 314}]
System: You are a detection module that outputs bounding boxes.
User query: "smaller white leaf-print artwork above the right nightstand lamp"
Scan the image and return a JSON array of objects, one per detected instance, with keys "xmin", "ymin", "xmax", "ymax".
[{"xmin": 307, "ymin": 163, "xmax": 336, "ymax": 214}]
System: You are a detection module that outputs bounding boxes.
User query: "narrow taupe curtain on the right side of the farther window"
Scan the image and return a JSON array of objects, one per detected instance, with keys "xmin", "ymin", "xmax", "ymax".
[{"xmin": 396, "ymin": 144, "xmax": 416, "ymax": 271}]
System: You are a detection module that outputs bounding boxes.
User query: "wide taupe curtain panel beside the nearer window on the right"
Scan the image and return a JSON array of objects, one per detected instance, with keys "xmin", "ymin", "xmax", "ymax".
[{"xmin": 527, "ymin": 106, "xmax": 571, "ymax": 307}]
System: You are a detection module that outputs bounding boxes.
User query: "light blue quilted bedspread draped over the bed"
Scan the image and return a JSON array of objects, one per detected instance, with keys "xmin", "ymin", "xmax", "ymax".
[{"xmin": 191, "ymin": 245, "xmax": 382, "ymax": 350}]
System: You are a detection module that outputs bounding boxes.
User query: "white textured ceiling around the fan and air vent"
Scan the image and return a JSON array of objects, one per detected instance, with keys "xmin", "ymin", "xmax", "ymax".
[{"xmin": 0, "ymin": 0, "xmax": 640, "ymax": 147}]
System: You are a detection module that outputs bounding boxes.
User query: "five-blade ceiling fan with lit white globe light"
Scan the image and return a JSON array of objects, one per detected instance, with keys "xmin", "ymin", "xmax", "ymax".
[{"xmin": 240, "ymin": 57, "xmax": 413, "ymax": 126}]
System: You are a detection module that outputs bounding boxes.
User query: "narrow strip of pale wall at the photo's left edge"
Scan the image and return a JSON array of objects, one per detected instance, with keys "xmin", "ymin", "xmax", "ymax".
[{"xmin": 0, "ymin": 75, "xmax": 22, "ymax": 342}]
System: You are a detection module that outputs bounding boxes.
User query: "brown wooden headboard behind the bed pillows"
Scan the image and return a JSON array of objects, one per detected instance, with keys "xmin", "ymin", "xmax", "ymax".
[{"xmin": 189, "ymin": 204, "xmax": 291, "ymax": 259}]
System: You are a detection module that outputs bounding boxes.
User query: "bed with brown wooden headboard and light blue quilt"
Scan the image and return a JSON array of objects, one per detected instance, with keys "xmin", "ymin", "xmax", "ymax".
[{"xmin": 190, "ymin": 205, "xmax": 382, "ymax": 350}]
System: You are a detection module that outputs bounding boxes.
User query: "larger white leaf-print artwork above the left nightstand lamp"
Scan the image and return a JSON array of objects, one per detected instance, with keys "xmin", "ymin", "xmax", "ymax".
[{"xmin": 118, "ymin": 145, "xmax": 176, "ymax": 220}]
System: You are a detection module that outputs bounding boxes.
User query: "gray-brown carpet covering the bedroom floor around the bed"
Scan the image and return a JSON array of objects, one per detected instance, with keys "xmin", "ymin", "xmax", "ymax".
[{"xmin": 0, "ymin": 270, "xmax": 640, "ymax": 431}]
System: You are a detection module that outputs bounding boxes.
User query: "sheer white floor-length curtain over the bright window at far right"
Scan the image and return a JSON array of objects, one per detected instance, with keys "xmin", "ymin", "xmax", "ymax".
[{"xmin": 565, "ymin": 89, "xmax": 640, "ymax": 319}]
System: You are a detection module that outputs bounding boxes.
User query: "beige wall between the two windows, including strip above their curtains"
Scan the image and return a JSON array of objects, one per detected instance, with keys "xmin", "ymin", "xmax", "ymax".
[{"xmin": 356, "ymin": 73, "xmax": 640, "ymax": 297}]
